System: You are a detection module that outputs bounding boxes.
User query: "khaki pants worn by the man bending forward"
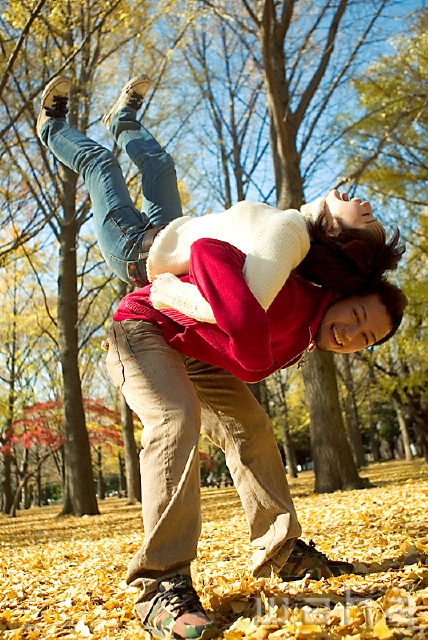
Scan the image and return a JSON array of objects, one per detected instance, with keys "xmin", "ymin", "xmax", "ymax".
[{"xmin": 107, "ymin": 320, "xmax": 301, "ymax": 601}]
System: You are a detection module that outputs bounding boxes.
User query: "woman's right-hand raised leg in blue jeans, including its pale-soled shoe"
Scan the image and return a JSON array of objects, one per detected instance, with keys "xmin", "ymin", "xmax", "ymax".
[{"xmin": 103, "ymin": 76, "xmax": 182, "ymax": 226}]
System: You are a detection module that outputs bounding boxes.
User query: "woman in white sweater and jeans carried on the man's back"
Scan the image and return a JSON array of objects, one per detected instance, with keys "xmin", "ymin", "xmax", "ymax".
[{"xmin": 37, "ymin": 76, "xmax": 404, "ymax": 323}]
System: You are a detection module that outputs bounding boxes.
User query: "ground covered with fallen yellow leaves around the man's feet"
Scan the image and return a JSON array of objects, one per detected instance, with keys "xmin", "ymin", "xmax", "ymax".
[{"xmin": 0, "ymin": 461, "xmax": 428, "ymax": 640}]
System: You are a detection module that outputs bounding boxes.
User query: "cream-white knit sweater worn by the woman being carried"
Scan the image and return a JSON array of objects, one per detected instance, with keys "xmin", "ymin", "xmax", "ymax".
[{"xmin": 147, "ymin": 198, "xmax": 325, "ymax": 324}]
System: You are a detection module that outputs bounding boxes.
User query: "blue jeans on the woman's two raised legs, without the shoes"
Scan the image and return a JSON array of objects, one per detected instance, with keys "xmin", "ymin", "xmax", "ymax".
[{"xmin": 41, "ymin": 108, "xmax": 182, "ymax": 285}]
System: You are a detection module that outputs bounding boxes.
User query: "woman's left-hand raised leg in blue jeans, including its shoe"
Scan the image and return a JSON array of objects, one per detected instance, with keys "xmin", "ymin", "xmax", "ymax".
[{"xmin": 37, "ymin": 78, "xmax": 150, "ymax": 284}]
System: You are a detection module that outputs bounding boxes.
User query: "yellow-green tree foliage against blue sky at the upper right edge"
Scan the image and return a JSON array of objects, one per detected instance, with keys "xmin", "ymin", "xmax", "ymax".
[{"xmin": 344, "ymin": 8, "xmax": 428, "ymax": 211}]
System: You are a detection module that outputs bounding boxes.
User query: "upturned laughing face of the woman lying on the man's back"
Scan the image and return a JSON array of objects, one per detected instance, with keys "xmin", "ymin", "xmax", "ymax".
[{"xmin": 326, "ymin": 189, "xmax": 384, "ymax": 235}]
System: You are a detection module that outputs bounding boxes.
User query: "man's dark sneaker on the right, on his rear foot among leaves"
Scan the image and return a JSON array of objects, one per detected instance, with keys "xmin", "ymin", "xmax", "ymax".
[{"xmin": 279, "ymin": 539, "xmax": 354, "ymax": 582}]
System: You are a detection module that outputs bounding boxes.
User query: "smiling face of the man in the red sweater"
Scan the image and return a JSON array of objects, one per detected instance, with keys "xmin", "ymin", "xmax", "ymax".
[{"xmin": 315, "ymin": 293, "xmax": 391, "ymax": 353}]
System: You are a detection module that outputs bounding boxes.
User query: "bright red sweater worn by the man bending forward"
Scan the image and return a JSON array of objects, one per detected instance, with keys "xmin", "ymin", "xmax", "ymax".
[{"xmin": 113, "ymin": 238, "xmax": 332, "ymax": 382}]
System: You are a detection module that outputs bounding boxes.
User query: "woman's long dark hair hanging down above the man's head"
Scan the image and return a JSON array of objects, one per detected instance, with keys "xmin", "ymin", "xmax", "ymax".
[{"xmin": 297, "ymin": 215, "xmax": 405, "ymax": 296}]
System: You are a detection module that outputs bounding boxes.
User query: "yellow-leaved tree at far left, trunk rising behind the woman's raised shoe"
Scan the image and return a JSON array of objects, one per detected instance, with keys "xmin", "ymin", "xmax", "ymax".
[{"xmin": 0, "ymin": 0, "xmax": 193, "ymax": 515}]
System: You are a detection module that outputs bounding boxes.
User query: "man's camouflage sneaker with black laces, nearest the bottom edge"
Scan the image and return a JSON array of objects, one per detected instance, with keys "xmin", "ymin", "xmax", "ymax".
[{"xmin": 136, "ymin": 575, "xmax": 219, "ymax": 640}]
